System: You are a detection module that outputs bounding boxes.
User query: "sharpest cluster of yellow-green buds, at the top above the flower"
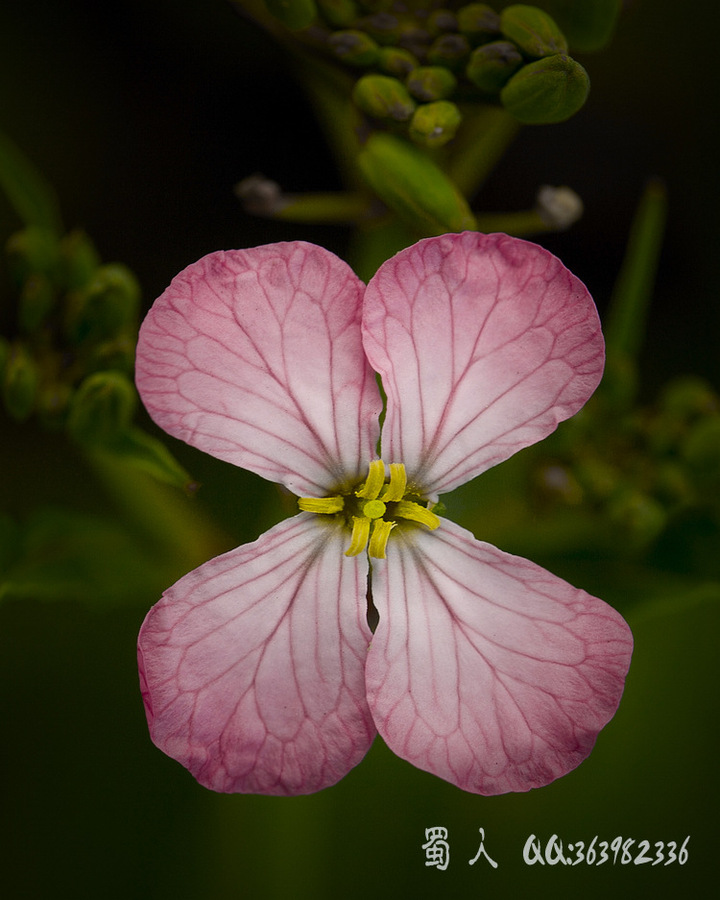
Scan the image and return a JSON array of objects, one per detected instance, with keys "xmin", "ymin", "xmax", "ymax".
[{"xmin": 318, "ymin": 0, "xmax": 589, "ymax": 142}]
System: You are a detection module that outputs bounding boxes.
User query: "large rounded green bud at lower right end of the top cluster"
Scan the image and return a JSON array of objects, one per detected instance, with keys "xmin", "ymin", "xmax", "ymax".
[{"xmin": 500, "ymin": 54, "xmax": 590, "ymax": 125}]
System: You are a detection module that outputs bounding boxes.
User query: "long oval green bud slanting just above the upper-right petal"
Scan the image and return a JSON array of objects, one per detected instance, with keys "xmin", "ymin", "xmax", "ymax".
[{"xmin": 358, "ymin": 133, "xmax": 476, "ymax": 235}]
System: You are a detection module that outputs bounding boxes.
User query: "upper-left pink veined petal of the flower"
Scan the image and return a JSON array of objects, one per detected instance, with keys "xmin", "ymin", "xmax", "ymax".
[{"xmin": 136, "ymin": 241, "xmax": 382, "ymax": 496}]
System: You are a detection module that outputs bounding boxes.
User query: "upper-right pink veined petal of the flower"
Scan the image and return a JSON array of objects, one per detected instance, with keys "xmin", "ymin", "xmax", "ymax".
[{"xmin": 363, "ymin": 232, "xmax": 604, "ymax": 498}]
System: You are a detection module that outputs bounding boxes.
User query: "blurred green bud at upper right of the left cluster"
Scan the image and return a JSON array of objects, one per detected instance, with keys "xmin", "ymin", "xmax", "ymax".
[{"xmin": 66, "ymin": 263, "xmax": 140, "ymax": 342}]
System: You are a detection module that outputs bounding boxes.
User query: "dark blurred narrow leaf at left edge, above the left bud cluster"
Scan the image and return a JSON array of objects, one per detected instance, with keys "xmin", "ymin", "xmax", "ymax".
[{"xmin": 0, "ymin": 133, "xmax": 63, "ymax": 236}]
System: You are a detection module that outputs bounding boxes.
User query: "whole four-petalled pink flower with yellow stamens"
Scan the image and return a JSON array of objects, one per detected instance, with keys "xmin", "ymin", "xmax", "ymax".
[{"xmin": 137, "ymin": 232, "xmax": 632, "ymax": 794}]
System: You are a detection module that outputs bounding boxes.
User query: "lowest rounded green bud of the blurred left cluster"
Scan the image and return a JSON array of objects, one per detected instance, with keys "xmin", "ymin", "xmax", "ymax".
[{"xmin": 67, "ymin": 372, "xmax": 137, "ymax": 444}]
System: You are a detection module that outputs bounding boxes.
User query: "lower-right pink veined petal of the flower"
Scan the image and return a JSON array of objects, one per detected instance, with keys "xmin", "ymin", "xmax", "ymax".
[{"xmin": 366, "ymin": 520, "xmax": 632, "ymax": 794}]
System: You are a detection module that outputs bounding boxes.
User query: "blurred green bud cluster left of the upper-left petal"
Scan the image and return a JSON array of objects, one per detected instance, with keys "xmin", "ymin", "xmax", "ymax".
[{"xmin": 0, "ymin": 227, "xmax": 140, "ymax": 445}]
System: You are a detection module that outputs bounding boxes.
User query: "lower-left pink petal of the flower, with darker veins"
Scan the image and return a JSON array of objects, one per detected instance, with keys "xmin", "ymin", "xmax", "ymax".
[{"xmin": 138, "ymin": 513, "xmax": 375, "ymax": 794}]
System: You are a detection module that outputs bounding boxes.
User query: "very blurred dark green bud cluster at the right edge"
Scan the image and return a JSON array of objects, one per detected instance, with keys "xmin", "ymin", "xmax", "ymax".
[{"xmin": 534, "ymin": 376, "xmax": 720, "ymax": 550}]
